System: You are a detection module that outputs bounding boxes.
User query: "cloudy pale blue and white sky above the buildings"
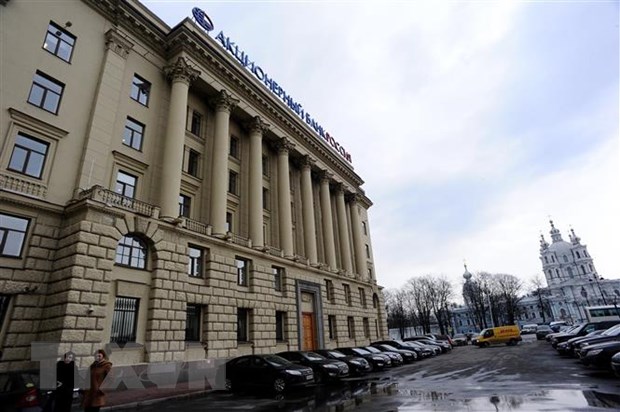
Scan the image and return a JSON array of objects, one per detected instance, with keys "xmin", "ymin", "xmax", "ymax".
[{"xmin": 144, "ymin": 0, "xmax": 620, "ymax": 288}]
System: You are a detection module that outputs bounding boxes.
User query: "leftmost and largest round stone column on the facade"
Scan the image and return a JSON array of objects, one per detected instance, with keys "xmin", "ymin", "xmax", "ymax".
[{"xmin": 159, "ymin": 57, "xmax": 200, "ymax": 218}]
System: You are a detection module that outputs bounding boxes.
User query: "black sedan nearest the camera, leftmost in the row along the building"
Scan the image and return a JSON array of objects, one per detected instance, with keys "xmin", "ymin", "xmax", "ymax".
[{"xmin": 225, "ymin": 355, "xmax": 314, "ymax": 393}]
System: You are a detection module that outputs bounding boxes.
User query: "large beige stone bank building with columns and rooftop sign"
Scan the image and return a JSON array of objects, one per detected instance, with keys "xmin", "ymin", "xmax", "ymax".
[{"xmin": 0, "ymin": 0, "xmax": 387, "ymax": 370}]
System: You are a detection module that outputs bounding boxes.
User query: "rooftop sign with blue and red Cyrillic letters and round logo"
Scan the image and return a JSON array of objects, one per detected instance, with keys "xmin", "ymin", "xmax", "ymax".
[{"xmin": 192, "ymin": 7, "xmax": 352, "ymax": 163}]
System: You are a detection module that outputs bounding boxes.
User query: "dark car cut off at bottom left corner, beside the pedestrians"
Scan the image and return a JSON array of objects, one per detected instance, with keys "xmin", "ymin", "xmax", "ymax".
[{"xmin": 0, "ymin": 370, "xmax": 47, "ymax": 412}]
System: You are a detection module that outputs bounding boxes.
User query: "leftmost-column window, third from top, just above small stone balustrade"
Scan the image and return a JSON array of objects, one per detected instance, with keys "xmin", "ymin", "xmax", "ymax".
[{"xmin": 8, "ymin": 133, "xmax": 49, "ymax": 179}]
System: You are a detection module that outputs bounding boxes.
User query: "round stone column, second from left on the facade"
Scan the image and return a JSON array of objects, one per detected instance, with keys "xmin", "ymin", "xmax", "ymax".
[{"xmin": 210, "ymin": 90, "xmax": 239, "ymax": 236}]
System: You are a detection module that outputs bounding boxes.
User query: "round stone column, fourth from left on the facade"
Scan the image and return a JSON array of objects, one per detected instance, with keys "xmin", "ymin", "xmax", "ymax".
[{"xmin": 278, "ymin": 137, "xmax": 294, "ymax": 257}]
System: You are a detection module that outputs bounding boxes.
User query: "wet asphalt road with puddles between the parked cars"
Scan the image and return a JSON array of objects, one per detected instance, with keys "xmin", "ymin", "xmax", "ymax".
[{"xmin": 131, "ymin": 335, "xmax": 620, "ymax": 412}]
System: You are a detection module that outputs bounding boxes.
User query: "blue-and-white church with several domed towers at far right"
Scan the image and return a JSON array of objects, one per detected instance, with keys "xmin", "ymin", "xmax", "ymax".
[{"xmin": 540, "ymin": 220, "xmax": 598, "ymax": 287}]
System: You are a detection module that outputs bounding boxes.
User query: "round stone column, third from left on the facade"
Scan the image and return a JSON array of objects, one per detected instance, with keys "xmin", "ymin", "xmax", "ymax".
[{"xmin": 247, "ymin": 116, "xmax": 269, "ymax": 248}]
